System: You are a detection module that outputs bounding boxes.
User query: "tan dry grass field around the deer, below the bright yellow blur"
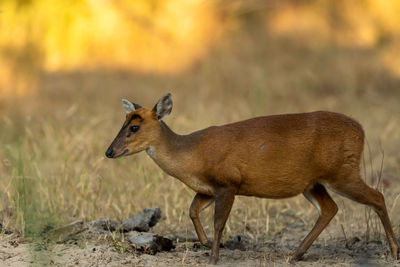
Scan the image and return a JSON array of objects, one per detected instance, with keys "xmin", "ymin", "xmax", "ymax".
[{"xmin": 0, "ymin": 3, "xmax": 400, "ymax": 264}]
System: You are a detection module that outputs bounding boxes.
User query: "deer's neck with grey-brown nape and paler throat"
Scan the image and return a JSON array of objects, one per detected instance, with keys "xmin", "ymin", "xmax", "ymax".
[{"xmin": 146, "ymin": 121, "xmax": 201, "ymax": 180}]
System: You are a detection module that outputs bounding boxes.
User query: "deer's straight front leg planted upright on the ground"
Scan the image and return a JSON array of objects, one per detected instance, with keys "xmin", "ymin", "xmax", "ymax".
[{"xmin": 210, "ymin": 188, "xmax": 236, "ymax": 264}]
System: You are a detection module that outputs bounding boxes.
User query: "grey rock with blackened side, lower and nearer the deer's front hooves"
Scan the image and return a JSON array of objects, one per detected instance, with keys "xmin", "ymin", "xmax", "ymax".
[{"xmin": 128, "ymin": 231, "xmax": 175, "ymax": 255}]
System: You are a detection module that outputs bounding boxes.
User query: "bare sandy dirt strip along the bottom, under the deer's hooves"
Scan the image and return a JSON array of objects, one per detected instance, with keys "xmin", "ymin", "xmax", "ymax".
[{"xmin": 0, "ymin": 225, "xmax": 400, "ymax": 266}]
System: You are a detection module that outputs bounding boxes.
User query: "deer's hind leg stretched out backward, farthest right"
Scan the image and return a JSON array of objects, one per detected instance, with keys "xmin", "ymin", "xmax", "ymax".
[{"xmin": 329, "ymin": 172, "xmax": 399, "ymax": 260}]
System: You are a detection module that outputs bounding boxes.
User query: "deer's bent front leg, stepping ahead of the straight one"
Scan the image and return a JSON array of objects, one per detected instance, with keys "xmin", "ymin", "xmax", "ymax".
[{"xmin": 189, "ymin": 193, "xmax": 214, "ymax": 248}]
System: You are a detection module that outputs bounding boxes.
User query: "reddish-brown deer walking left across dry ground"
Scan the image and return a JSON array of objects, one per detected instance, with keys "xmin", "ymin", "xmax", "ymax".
[{"xmin": 105, "ymin": 93, "xmax": 399, "ymax": 264}]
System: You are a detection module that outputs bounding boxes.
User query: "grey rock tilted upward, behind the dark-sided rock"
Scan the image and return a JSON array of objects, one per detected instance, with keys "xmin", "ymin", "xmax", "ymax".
[{"xmin": 121, "ymin": 207, "xmax": 161, "ymax": 232}]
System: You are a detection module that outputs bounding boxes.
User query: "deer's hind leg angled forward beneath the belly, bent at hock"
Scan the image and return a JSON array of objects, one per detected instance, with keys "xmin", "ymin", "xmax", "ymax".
[{"xmin": 291, "ymin": 184, "xmax": 338, "ymax": 262}]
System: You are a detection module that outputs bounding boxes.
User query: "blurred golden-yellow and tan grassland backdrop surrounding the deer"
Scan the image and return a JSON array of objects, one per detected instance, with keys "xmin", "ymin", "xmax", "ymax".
[{"xmin": 0, "ymin": 0, "xmax": 400, "ymax": 246}]
